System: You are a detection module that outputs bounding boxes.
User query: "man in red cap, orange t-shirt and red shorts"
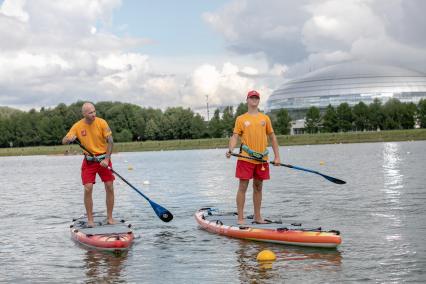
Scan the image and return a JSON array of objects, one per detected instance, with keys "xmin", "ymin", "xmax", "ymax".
[{"xmin": 226, "ymin": 90, "xmax": 281, "ymax": 224}]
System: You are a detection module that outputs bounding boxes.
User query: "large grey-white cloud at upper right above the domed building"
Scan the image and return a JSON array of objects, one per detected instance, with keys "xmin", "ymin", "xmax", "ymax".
[{"xmin": 204, "ymin": 0, "xmax": 426, "ymax": 76}]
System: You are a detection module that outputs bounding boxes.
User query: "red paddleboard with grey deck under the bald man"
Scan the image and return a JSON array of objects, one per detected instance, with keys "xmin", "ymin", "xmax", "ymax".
[{"xmin": 70, "ymin": 216, "xmax": 134, "ymax": 253}]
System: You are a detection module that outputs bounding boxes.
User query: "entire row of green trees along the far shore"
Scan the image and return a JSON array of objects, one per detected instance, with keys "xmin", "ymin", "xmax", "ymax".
[{"xmin": 0, "ymin": 97, "xmax": 426, "ymax": 147}]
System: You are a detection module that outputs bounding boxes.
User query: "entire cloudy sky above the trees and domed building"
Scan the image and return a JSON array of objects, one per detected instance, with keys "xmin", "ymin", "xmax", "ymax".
[{"xmin": 0, "ymin": 0, "xmax": 426, "ymax": 116}]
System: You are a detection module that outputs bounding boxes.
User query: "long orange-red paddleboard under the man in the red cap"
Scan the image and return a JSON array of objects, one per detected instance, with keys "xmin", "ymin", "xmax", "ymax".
[{"xmin": 195, "ymin": 207, "xmax": 342, "ymax": 248}]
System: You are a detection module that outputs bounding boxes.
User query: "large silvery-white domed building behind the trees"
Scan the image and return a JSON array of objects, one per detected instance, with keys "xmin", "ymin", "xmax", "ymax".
[{"xmin": 266, "ymin": 62, "xmax": 426, "ymax": 113}]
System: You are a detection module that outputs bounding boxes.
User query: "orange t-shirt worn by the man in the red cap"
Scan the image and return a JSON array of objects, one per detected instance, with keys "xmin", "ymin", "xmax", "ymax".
[{"xmin": 234, "ymin": 112, "xmax": 274, "ymax": 164}]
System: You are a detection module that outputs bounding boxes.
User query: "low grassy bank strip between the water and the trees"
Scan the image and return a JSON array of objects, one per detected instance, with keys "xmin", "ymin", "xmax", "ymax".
[{"xmin": 0, "ymin": 129, "xmax": 426, "ymax": 156}]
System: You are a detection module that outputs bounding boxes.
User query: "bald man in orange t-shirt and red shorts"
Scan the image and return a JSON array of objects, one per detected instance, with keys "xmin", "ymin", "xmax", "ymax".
[{"xmin": 62, "ymin": 103, "xmax": 115, "ymax": 227}]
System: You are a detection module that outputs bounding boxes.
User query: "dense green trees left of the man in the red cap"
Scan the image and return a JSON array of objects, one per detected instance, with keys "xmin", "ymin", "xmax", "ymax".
[{"xmin": 0, "ymin": 101, "xmax": 247, "ymax": 147}]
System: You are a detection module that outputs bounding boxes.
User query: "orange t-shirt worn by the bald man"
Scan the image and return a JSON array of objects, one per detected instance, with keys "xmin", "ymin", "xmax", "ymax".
[{"xmin": 67, "ymin": 117, "xmax": 112, "ymax": 155}]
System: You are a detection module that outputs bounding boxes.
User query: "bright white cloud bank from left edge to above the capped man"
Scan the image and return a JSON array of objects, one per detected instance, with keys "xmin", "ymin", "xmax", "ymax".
[{"xmin": 0, "ymin": 0, "xmax": 282, "ymax": 113}]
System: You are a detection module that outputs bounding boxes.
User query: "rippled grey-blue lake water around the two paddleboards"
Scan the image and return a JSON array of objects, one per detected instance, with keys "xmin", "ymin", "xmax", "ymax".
[{"xmin": 0, "ymin": 141, "xmax": 426, "ymax": 283}]
